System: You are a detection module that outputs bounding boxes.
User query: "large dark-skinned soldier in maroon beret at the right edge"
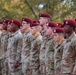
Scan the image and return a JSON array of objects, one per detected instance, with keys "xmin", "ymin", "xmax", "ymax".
[{"xmin": 61, "ymin": 20, "xmax": 76, "ymax": 75}]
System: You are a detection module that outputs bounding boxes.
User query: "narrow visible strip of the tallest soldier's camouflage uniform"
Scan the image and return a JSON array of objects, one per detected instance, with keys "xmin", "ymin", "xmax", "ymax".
[{"xmin": 39, "ymin": 30, "xmax": 47, "ymax": 75}]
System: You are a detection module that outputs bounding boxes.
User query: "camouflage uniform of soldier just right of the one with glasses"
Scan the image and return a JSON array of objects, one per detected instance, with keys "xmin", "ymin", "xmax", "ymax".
[{"xmin": 30, "ymin": 35, "xmax": 42, "ymax": 75}]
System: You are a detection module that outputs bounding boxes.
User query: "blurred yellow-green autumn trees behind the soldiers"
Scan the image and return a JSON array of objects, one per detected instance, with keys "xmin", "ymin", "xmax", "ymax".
[{"xmin": 0, "ymin": 0, "xmax": 76, "ymax": 22}]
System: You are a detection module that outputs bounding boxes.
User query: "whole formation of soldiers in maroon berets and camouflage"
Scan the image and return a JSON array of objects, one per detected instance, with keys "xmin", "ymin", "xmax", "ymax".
[{"xmin": 0, "ymin": 13, "xmax": 76, "ymax": 75}]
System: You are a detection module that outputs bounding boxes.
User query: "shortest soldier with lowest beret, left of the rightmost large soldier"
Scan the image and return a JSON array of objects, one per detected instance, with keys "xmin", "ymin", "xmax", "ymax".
[{"xmin": 53, "ymin": 28, "xmax": 65, "ymax": 75}]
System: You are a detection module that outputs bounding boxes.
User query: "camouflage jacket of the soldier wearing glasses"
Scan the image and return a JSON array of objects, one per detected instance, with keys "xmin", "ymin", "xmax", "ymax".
[{"xmin": 21, "ymin": 31, "xmax": 32, "ymax": 62}]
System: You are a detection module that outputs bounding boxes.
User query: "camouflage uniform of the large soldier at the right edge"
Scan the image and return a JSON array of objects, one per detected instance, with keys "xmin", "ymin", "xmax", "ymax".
[{"xmin": 61, "ymin": 33, "xmax": 76, "ymax": 75}]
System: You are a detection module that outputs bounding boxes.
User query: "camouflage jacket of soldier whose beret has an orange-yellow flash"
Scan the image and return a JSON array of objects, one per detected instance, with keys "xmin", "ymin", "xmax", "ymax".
[{"xmin": 7, "ymin": 30, "xmax": 22, "ymax": 63}]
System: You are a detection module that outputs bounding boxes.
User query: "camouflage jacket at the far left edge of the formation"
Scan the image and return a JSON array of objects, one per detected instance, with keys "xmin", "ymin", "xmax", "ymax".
[{"xmin": 0, "ymin": 32, "xmax": 9, "ymax": 58}]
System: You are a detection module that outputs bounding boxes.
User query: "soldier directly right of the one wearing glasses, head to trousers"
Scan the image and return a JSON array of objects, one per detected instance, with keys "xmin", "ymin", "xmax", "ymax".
[{"xmin": 30, "ymin": 22, "xmax": 42, "ymax": 75}]
